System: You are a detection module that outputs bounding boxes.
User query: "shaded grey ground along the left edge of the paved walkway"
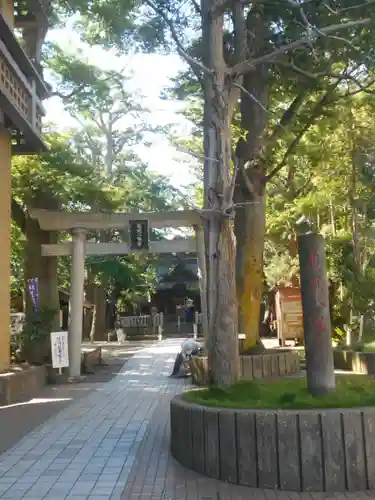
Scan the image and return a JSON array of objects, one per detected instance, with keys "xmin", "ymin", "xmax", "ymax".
[{"xmin": 0, "ymin": 342, "xmax": 152, "ymax": 453}]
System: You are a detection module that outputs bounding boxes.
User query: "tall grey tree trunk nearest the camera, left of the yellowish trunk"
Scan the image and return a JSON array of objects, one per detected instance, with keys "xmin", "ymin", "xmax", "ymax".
[{"xmin": 201, "ymin": 0, "xmax": 239, "ymax": 386}]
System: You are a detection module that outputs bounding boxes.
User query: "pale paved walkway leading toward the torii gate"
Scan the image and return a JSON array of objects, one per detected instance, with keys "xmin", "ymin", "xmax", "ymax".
[{"xmin": 0, "ymin": 341, "xmax": 375, "ymax": 500}]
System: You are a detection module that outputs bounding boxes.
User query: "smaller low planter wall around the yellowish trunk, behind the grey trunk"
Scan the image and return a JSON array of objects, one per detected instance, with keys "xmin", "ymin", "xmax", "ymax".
[{"xmin": 190, "ymin": 349, "xmax": 300, "ymax": 386}]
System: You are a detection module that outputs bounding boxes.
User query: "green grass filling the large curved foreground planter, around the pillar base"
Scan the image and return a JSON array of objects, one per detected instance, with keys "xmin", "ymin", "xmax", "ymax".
[{"xmin": 184, "ymin": 375, "xmax": 375, "ymax": 409}]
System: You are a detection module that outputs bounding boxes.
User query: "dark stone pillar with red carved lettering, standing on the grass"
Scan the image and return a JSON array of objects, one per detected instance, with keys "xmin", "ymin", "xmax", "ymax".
[{"xmin": 298, "ymin": 232, "xmax": 335, "ymax": 396}]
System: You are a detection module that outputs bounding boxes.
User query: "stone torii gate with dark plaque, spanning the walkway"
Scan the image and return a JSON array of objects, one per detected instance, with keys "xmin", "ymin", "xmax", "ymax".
[{"xmin": 29, "ymin": 209, "xmax": 207, "ymax": 377}]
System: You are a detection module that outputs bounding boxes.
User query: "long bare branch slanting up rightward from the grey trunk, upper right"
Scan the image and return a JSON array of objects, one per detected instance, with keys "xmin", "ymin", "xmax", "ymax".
[{"xmin": 231, "ymin": 18, "xmax": 370, "ymax": 77}]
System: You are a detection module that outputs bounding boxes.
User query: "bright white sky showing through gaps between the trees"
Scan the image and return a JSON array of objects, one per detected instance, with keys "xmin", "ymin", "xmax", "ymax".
[{"xmin": 44, "ymin": 21, "xmax": 194, "ymax": 188}]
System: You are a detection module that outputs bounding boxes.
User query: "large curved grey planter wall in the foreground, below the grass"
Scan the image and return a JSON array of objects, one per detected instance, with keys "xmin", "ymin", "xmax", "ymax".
[{"xmin": 171, "ymin": 396, "xmax": 375, "ymax": 492}]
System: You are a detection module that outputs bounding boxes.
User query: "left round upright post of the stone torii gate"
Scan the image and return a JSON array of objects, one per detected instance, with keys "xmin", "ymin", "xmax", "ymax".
[{"xmin": 68, "ymin": 229, "xmax": 86, "ymax": 377}]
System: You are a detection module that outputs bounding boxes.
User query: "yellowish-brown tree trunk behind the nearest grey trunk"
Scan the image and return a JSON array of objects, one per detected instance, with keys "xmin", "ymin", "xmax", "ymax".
[{"xmin": 235, "ymin": 11, "xmax": 268, "ymax": 351}]
